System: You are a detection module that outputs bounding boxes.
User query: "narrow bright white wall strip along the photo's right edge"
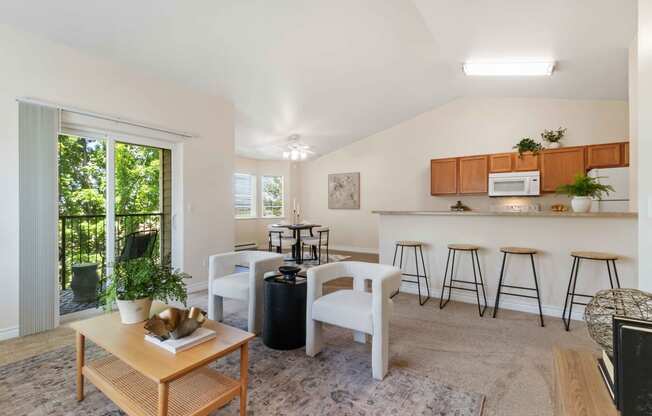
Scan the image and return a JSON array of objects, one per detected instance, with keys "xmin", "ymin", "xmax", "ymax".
[{"xmin": 637, "ymin": 0, "xmax": 652, "ymax": 292}]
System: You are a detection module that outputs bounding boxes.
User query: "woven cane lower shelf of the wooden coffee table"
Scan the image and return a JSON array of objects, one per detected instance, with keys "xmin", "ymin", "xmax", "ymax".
[{"xmin": 83, "ymin": 355, "xmax": 240, "ymax": 416}]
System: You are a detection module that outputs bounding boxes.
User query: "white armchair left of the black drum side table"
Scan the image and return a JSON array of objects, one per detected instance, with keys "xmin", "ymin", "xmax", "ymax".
[{"xmin": 208, "ymin": 251, "xmax": 283, "ymax": 334}]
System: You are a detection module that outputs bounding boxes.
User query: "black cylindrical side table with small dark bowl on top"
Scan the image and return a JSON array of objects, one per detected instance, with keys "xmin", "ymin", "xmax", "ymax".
[{"xmin": 263, "ymin": 266, "xmax": 307, "ymax": 350}]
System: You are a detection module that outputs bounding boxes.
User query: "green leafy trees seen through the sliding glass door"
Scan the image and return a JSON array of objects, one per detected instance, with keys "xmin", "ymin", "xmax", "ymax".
[{"xmin": 58, "ymin": 135, "xmax": 161, "ymax": 286}]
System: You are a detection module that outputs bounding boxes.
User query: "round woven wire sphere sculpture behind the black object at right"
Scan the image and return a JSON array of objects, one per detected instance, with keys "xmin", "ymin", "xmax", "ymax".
[{"xmin": 584, "ymin": 289, "xmax": 652, "ymax": 355}]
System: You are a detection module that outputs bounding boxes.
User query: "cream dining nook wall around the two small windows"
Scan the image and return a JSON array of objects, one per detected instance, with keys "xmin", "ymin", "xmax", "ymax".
[{"xmin": 234, "ymin": 157, "xmax": 299, "ymax": 248}]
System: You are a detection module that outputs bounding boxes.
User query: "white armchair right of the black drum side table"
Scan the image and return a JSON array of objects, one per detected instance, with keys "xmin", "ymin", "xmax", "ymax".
[{"xmin": 306, "ymin": 261, "xmax": 401, "ymax": 380}]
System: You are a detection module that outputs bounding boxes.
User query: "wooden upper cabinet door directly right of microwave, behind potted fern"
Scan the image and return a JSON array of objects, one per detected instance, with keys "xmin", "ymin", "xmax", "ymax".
[{"xmin": 540, "ymin": 146, "xmax": 586, "ymax": 192}]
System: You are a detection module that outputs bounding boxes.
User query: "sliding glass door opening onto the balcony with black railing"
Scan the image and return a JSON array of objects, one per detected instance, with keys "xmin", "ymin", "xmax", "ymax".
[{"xmin": 59, "ymin": 134, "xmax": 172, "ymax": 315}]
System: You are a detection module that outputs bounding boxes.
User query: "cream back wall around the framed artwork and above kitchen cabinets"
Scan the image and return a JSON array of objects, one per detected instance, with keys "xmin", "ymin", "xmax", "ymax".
[{"xmin": 301, "ymin": 98, "xmax": 629, "ymax": 251}]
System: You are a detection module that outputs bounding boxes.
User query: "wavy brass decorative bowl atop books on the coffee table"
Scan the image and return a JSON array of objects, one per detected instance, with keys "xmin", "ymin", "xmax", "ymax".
[{"xmin": 145, "ymin": 307, "xmax": 206, "ymax": 341}]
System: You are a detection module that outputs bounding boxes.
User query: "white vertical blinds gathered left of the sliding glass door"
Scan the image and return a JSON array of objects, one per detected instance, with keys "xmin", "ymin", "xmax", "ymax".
[{"xmin": 18, "ymin": 102, "xmax": 59, "ymax": 336}]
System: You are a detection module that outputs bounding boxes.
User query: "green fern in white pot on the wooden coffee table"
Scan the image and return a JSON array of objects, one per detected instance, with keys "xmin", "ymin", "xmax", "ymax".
[{"xmin": 99, "ymin": 257, "xmax": 190, "ymax": 324}]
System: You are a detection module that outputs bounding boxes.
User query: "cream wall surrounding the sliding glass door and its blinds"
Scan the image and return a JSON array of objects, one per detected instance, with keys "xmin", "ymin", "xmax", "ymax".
[{"xmin": 0, "ymin": 25, "xmax": 234, "ymax": 336}]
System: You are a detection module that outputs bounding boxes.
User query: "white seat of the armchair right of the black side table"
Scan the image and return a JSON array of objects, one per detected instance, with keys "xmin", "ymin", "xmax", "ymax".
[{"xmin": 312, "ymin": 290, "xmax": 392, "ymax": 335}]
